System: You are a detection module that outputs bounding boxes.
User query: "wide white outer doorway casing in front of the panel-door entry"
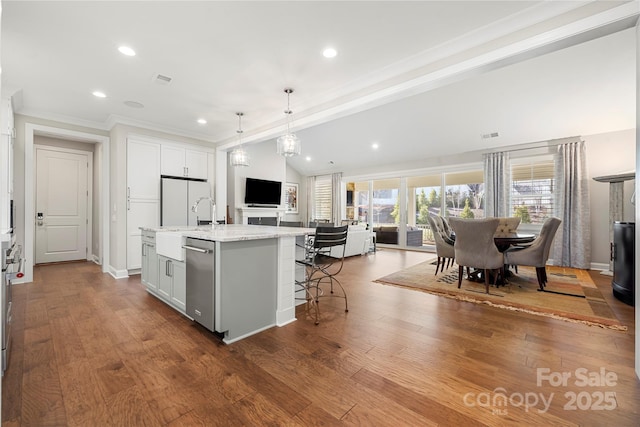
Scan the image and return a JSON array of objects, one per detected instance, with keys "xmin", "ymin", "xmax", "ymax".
[{"xmin": 24, "ymin": 123, "xmax": 110, "ymax": 283}]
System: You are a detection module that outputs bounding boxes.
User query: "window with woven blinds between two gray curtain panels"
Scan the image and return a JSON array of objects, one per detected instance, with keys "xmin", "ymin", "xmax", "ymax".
[{"xmin": 511, "ymin": 156, "xmax": 555, "ymax": 224}]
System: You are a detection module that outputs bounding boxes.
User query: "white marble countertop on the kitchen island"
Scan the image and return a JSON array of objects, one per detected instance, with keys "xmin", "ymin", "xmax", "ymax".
[{"xmin": 140, "ymin": 224, "xmax": 316, "ymax": 242}]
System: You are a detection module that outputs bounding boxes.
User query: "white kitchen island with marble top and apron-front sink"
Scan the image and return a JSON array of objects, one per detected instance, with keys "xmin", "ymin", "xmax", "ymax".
[{"xmin": 141, "ymin": 224, "xmax": 315, "ymax": 343}]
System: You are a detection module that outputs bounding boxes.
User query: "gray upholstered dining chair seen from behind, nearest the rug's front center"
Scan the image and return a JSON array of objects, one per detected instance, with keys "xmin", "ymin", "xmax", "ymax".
[{"xmin": 449, "ymin": 218, "xmax": 504, "ymax": 293}]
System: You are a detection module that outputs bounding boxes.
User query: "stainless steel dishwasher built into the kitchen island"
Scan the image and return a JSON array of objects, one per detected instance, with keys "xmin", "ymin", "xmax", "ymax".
[{"xmin": 182, "ymin": 237, "xmax": 215, "ymax": 332}]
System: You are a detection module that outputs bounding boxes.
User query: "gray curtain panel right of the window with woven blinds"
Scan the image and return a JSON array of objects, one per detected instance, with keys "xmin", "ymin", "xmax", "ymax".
[{"xmin": 552, "ymin": 141, "xmax": 591, "ymax": 269}]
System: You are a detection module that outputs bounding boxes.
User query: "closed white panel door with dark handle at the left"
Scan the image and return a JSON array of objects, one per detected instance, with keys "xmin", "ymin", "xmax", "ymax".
[{"xmin": 35, "ymin": 148, "xmax": 89, "ymax": 264}]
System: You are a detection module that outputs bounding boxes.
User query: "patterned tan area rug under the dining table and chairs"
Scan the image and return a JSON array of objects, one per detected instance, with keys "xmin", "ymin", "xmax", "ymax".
[{"xmin": 375, "ymin": 261, "xmax": 627, "ymax": 331}]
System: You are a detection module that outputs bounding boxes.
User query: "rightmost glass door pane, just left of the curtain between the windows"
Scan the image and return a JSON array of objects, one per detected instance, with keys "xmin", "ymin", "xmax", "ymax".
[{"xmin": 444, "ymin": 170, "xmax": 484, "ymax": 218}]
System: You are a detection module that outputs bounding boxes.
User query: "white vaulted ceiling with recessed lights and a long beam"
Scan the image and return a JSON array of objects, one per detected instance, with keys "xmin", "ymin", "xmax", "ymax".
[{"xmin": 0, "ymin": 1, "xmax": 638, "ymax": 175}]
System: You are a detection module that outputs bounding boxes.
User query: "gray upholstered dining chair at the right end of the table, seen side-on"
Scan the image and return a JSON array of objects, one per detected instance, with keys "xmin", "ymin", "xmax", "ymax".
[{"xmin": 504, "ymin": 217, "xmax": 562, "ymax": 291}]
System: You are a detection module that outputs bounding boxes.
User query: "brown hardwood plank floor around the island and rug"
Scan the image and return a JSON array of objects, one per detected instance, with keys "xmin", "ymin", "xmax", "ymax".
[{"xmin": 2, "ymin": 249, "xmax": 640, "ymax": 427}]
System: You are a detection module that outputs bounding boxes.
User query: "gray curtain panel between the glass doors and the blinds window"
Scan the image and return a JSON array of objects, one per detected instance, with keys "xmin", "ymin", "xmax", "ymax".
[{"xmin": 484, "ymin": 152, "xmax": 511, "ymax": 218}]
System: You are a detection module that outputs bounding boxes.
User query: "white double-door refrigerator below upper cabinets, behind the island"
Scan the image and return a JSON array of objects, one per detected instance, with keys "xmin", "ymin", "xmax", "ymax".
[{"xmin": 160, "ymin": 178, "xmax": 211, "ymax": 226}]
